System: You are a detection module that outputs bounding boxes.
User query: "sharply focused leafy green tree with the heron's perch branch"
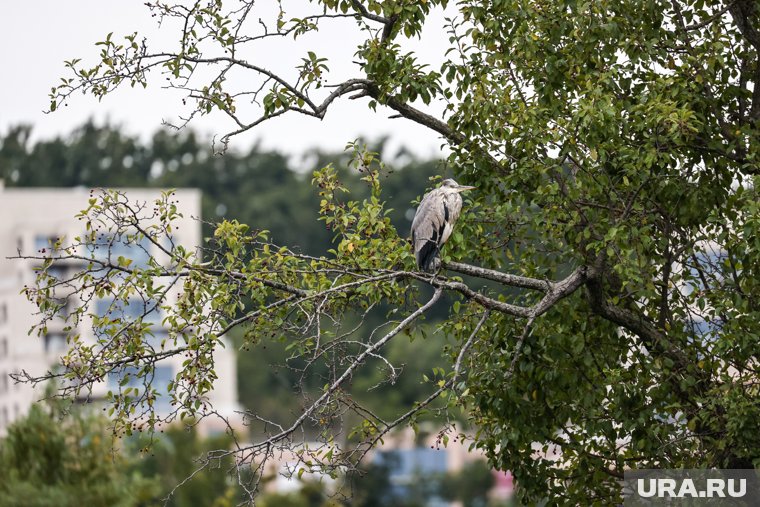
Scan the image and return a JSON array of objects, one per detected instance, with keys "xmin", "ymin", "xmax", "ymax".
[{"xmin": 16, "ymin": 0, "xmax": 760, "ymax": 504}]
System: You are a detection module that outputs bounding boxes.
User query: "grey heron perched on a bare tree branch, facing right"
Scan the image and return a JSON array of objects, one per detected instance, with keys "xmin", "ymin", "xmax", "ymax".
[{"xmin": 412, "ymin": 178, "xmax": 475, "ymax": 273}]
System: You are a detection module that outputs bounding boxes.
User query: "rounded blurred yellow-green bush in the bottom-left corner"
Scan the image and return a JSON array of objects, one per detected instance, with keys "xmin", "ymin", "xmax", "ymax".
[{"xmin": 0, "ymin": 403, "xmax": 157, "ymax": 507}]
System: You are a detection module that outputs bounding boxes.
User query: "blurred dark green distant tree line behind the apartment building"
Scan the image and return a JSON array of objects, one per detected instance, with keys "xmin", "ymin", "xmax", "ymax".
[{"xmin": 0, "ymin": 121, "xmax": 444, "ymax": 253}]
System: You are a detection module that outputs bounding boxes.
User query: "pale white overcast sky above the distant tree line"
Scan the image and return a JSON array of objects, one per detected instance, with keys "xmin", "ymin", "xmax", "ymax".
[{"xmin": 0, "ymin": 0, "xmax": 446, "ymax": 161}]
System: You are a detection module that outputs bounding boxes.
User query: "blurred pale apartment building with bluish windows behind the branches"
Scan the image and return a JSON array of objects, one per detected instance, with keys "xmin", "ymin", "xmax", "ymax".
[{"xmin": 0, "ymin": 184, "xmax": 240, "ymax": 436}]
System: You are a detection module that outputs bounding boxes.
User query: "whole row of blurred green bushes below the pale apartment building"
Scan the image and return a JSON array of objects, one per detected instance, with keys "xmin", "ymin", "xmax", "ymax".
[{"xmin": 0, "ymin": 394, "xmax": 239, "ymax": 507}]
